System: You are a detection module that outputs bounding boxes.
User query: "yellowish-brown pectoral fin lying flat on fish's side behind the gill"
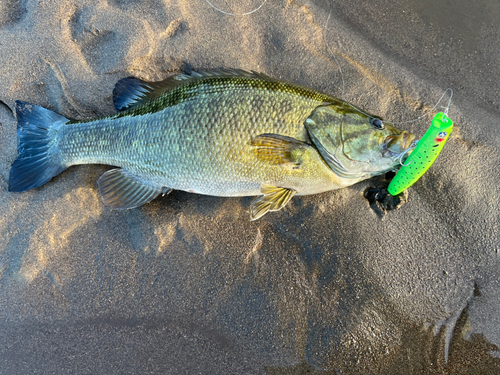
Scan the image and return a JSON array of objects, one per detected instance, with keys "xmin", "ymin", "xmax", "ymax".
[{"xmin": 250, "ymin": 134, "xmax": 311, "ymax": 167}]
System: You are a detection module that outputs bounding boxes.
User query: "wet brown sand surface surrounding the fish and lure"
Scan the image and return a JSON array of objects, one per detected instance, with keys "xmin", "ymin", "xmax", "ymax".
[{"xmin": 0, "ymin": 0, "xmax": 500, "ymax": 375}]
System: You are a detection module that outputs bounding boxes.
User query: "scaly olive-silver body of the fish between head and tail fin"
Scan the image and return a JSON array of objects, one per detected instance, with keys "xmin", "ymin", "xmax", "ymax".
[{"xmin": 59, "ymin": 78, "xmax": 327, "ymax": 196}]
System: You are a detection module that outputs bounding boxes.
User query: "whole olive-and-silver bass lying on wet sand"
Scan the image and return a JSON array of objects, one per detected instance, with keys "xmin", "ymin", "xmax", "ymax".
[{"xmin": 8, "ymin": 69, "xmax": 415, "ymax": 220}]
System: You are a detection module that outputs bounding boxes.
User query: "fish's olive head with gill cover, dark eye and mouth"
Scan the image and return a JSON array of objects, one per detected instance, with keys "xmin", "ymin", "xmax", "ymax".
[{"xmin": 305, "ymin": 101, "xmax": 415, "ymax": 180}]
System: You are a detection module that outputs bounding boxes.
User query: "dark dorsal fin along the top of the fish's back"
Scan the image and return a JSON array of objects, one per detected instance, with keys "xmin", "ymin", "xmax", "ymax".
[{"xmin": 113, "ymin": 69, "xmax": 279, "ymax": 111}]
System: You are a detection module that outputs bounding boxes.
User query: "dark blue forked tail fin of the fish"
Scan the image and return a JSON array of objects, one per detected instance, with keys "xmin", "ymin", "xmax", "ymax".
[{"xmin": 9, "ymin": 101, "xmax": 69, "ymax": 192}]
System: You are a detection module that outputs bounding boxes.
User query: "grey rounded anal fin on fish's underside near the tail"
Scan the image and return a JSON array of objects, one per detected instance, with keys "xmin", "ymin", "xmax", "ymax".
[{"xmin": 97, "ymin": 169, "xmax": 172, "ymax": 210}]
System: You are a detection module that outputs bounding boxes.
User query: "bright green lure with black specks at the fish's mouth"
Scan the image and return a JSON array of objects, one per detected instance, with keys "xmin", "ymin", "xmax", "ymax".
[{"xmin": 387, "ymin": 112, "xmax": 453, "ymax": 195}]
